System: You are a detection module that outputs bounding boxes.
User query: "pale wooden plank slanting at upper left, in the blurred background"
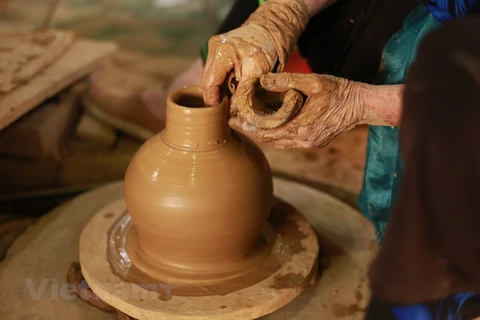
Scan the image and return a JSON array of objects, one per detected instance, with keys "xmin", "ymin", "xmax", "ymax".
[{"xmin": 0, "ymin": 39, "xmax": 116, "ymax": 130}]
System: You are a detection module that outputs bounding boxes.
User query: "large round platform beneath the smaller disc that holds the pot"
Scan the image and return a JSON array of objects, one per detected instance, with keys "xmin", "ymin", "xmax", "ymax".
[{"xmin": 0, "ymin": 179, "xmax": 378, "ymax": 320}]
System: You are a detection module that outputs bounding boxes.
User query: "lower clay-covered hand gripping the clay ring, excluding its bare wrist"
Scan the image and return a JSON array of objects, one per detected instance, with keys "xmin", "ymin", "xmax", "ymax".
[{"xmin": 230, "ymin": 73, "xmax": 366, "ymax": 149}]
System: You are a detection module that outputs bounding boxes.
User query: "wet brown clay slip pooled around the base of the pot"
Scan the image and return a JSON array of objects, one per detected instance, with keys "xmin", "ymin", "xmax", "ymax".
[{"xmin": 107, "ymin": 199, "xmax": 308, "ymax": 301}]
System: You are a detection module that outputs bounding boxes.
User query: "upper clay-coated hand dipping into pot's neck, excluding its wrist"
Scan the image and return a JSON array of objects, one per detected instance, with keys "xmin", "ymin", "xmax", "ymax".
[{"xmin": 201, "ymin": 24, "xmax": 278, "ymax": 105}]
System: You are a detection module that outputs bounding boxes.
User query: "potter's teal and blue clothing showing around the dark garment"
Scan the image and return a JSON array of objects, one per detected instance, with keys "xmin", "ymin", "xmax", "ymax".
[{"xmin": 360, "ymin": 0, "xmax": 480, "ymax": 320}]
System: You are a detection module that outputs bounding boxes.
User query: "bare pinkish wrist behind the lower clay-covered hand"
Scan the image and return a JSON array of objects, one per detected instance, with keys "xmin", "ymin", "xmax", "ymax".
[{"xmin": 361, "ymin": 84, "xmax": 405, "ymax": 126}]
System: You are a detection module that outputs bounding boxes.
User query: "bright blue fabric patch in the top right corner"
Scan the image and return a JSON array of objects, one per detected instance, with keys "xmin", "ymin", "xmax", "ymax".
[{"xmin": 427, "ymin": 0, "xmax": 478, "ymax": 22}]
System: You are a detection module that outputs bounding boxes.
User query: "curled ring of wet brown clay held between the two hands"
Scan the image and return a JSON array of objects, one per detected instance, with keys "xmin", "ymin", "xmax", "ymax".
[{"xmin": 227, "ymin": 73, "xmax": 304, "ymax": 130}]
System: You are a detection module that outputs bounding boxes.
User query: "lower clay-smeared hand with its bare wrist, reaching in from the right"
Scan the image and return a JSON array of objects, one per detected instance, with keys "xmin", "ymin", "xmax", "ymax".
[{"xmin": 230, "ymin": 73, "xmax": 404, "ymax": 148}]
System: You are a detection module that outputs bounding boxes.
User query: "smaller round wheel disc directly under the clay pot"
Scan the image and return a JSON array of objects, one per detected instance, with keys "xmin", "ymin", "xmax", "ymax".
[{"xmin": 80, "ymin": 194, "xmax": 319, "ymax": 320}]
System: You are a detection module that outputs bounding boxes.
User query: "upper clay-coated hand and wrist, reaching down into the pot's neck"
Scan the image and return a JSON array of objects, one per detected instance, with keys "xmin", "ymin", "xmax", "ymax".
[{"xmin": 201, "ymin": 0, "xmax": 308, "ymax": 105}]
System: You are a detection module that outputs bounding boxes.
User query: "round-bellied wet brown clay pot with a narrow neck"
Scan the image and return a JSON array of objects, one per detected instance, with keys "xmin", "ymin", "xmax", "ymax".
[{"xmin": 125, "ymin": 87, "xmax": 273, "ymax": 282}]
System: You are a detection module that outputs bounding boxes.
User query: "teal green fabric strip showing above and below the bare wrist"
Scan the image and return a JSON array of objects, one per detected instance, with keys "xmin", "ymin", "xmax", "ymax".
[{"xmin": 359, "ymin": 4, "xmax": 442, "ymax": 243}]
